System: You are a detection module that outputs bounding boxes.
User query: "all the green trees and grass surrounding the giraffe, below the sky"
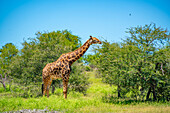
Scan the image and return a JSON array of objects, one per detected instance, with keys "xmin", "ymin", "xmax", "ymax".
[{"xmin": 0, "ymin": 23, "xmax": 170, "ymax": 113}]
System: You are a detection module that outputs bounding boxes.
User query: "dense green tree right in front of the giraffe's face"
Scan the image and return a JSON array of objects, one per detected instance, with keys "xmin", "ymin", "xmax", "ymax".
[{"xmin": 92, "ymin": 41, "xmax": 139, "ymax": 97}]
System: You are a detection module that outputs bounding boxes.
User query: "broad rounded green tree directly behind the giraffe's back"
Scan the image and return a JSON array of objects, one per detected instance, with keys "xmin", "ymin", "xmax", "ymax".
[{"xmin": 7, "ymin": 30, "xmax": 89, "ymax": 96}]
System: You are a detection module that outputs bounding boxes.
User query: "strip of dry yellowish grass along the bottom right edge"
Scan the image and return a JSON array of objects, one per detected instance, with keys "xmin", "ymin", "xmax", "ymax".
[{"xmin": 76, "ymin": 105, "xmax": 170, "ymax": 113}]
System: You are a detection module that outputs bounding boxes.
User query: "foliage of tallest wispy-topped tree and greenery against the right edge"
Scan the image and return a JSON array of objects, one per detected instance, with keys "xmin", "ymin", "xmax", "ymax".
[{"xmin": 125, "ymin": 24, "xmax": 170, "ymax": 100}]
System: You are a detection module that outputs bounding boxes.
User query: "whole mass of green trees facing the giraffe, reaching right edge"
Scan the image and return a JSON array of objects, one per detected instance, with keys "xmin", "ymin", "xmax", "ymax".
[{"xmin": 87, "ymin": 24, "xmax": 170, "ymax": 100}]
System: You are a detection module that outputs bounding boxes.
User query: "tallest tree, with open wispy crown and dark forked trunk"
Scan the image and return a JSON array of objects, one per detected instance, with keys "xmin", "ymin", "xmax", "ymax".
[{"xmin": 124, "ymin": 23, "xmax": 169, "ymax": 100}]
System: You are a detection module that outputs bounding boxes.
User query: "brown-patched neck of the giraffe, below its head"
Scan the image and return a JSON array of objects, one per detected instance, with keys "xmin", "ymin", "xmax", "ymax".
[{"xmin": 70, "ymin": 40, "xmax": 91, "ymax": 63}]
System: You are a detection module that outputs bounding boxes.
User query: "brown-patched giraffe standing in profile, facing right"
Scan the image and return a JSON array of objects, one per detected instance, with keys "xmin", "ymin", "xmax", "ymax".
[{"xmin": 42, "ymin": 36, "xmax": 102, "ymax": 99}]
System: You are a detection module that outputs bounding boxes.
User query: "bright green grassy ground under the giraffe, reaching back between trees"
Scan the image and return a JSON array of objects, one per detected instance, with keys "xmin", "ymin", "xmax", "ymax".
[{"xmin": 0, "ymin": 72, "xmax": 170, "ymax": 113}]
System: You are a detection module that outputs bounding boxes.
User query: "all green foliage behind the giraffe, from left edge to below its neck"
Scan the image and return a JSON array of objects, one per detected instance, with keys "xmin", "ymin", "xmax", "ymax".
[{"xmin": 0, "ymin": 30, "xmax": 89, "ymax": 97}]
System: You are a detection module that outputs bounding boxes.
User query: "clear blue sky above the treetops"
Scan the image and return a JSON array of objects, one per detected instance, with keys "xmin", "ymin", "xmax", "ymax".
[{"xmin": 0, "ymin": 0, "xmax": 170, "ymax": 49}]
